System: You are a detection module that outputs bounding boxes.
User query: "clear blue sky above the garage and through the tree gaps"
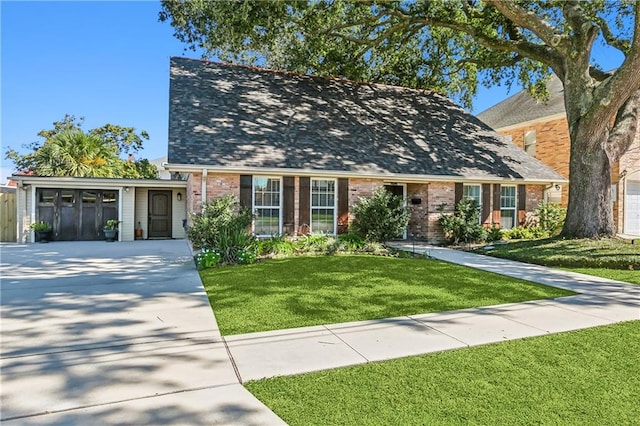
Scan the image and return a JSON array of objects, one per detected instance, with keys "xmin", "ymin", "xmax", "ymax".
[{"xmin": 0, "ymin": 1, "xmax": 619, "ymax": 183}]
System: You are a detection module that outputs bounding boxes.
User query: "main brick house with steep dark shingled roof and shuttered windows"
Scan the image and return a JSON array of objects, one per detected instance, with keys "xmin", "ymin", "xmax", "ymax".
[{"xmin": 165, "ymin": 58, "xmax": 566, "ymax": 241}]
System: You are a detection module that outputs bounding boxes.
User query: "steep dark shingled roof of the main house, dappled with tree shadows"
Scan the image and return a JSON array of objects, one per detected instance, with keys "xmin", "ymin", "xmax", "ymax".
[{"xmin": 168, "ymin": 58, "xmax": 563, "ymax": 181}]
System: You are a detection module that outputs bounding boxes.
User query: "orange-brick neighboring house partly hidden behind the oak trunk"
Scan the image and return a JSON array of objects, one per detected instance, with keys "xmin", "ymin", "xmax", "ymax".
[{"xmin": 478, "ymin": 76, "xmax": 640, "ymax": 235}]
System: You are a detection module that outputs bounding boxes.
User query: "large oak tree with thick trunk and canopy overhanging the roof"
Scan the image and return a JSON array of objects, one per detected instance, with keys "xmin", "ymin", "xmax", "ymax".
[{"xmin": 160, "ymin": 0, "xmax": 640, "ymax": 237}]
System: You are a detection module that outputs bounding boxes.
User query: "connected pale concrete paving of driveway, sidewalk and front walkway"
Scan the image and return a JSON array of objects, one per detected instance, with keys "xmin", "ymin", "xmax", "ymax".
[{"xmin": 0, "ymin": 241, "xmax": 640, "ymax": 425}]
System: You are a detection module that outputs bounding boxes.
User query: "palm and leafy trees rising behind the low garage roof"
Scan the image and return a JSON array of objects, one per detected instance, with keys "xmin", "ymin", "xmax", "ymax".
[{"xmin": 5, "ymin": 115, "xmax": 152, "ymax": 179}]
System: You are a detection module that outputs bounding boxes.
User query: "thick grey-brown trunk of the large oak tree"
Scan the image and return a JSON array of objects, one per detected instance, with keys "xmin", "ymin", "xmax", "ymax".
[{"xmin": 561, "ymin": 121, "xmax": 616, "ymax": 238}]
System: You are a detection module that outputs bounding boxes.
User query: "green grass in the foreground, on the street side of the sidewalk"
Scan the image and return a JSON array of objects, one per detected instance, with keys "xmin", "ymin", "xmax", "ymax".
[{"xmin": 246, "ymin": 321, "xmax": 640, "ymax": 426}]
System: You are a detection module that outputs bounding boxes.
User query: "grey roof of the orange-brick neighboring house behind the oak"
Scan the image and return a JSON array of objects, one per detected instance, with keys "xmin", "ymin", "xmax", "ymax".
[{"xmin": 478, "ymin": 75, "xmax": 566, "ymax": 129}]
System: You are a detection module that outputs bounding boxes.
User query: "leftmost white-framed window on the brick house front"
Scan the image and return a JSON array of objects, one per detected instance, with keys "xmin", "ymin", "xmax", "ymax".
[{"xmin": 253, "ymin": 176, "xmax": 282, "ymax": 236}]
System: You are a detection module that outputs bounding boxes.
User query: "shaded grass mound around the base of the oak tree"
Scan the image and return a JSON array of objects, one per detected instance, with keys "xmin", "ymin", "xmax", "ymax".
[{"xmin": 487, "ymin": 238, "xmax": 640, "ymax": 270}]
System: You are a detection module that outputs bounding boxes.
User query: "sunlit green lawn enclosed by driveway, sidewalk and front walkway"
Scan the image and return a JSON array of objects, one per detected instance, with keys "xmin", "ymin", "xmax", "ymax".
[{"xmin": 200, "ymin": 255, "xmax": 573, "ymax": 335}]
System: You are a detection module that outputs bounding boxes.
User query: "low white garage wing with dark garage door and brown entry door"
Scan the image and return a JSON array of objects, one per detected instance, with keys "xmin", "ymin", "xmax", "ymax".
[{"xmin": 11, "ymin": 175, "xmax": 187, "ymax": 242}]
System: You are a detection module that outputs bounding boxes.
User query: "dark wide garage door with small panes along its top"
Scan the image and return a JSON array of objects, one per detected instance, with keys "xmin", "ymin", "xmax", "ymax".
[{"xmin": 36, "ymin": 188, "xmax": 118, "ymax": 241}]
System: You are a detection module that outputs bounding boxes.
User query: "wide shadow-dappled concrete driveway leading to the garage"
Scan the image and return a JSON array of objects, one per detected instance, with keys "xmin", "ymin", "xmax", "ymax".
[{"xmin": 0, "ymin": 241, "xmax": 282, "ymax": 425}]
